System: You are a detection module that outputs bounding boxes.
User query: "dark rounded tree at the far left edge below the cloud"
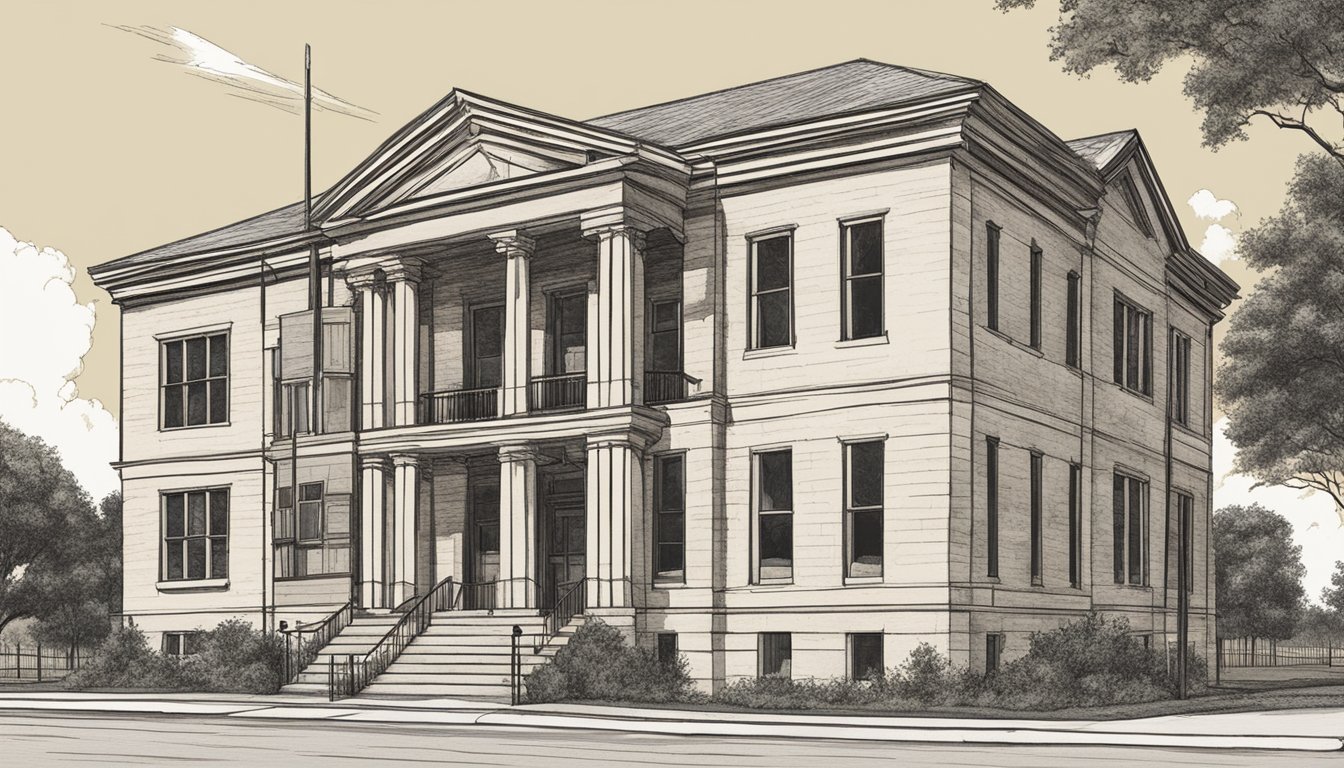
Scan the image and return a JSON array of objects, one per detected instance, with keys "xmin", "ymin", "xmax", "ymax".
[{"xmin": 0, "ymin": 421, "xmax": 93, "ymax": 629}]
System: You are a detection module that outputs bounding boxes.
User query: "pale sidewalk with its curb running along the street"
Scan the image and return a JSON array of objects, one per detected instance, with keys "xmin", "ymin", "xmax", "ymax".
[{"xmin": 0, "ymin": 693, "xmax": 1344, "ymax": 752}]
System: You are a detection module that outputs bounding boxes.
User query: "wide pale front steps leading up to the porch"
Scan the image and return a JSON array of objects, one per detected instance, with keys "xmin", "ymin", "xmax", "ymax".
[{"xmin": 282, "ymin": 611, "xmax": 583, "ymax": 701}]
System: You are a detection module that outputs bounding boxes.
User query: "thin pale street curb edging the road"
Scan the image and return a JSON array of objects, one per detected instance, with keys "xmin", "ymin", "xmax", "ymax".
[{"xmin": 0, "ymin": 697, "xmax": 1344, "ymax": 752}]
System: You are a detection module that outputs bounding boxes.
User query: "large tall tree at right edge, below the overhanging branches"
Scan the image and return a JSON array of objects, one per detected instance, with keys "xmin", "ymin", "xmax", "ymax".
[{"xmin": 1215, "ymin": 156, "xmax": 1344, "ymax": 525}]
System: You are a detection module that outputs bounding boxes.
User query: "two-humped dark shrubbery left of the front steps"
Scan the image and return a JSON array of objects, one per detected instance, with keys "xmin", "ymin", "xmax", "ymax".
[{"xmin": 65, "ymin": 619, "xmax": 285, "ymax": 693}]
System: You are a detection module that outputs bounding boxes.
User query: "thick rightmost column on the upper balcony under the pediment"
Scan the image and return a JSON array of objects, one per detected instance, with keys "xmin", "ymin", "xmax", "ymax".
[{"xmin": 583, "ymin": 217, "xmax": 644, "ymax": 408}]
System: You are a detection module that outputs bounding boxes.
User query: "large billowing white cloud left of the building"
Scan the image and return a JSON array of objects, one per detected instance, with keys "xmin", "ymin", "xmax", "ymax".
[{"xmin": 0, "ymin": 227, "xmax": 120, "ymax": 500}]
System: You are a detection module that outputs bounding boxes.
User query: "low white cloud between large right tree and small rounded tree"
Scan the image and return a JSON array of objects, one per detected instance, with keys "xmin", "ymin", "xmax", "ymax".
[{"xmin": 1214, "ymin": 417, "xmax": 1344, "ymax": 603}]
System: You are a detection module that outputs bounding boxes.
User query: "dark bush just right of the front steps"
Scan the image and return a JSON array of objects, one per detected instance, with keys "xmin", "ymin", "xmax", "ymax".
[{"xmin": 526, "ymin": 619, "xmax": 698, "ymax": 703}]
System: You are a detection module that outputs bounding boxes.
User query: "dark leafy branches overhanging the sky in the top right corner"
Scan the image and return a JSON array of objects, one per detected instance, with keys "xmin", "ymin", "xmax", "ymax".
[{"xmin": 997, "ymin": 0, "xmax": 1344, "ymax": 167}]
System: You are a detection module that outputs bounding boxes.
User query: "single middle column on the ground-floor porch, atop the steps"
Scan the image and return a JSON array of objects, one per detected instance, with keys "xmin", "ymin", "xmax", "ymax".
[{"xmin": 499, "ymin": 445, "xmax": 536, "ymax": 608}]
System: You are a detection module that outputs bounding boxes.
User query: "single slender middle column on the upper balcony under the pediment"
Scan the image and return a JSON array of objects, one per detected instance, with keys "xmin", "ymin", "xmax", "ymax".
[{"xmin": 489, "ymin": 230, "xmax": 536, "ymax": 416}]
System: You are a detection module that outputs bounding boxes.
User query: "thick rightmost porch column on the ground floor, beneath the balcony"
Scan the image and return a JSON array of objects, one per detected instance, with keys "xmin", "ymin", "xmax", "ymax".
[{"xmin": 585, "ymin": 434, "xmax": 644, "ymax": 608}]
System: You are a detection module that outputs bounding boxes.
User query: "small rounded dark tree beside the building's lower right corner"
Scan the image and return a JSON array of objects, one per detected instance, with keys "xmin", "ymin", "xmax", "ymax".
[{"xmin": 1214, "ymin": 504, "xmax": 1306, "ymax": 640}]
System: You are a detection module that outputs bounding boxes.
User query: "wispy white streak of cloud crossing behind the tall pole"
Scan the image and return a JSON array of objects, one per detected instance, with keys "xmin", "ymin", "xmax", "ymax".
[{"xmin": 110, "ymin": 24, "xmax": 378, "ymax": 121}]
